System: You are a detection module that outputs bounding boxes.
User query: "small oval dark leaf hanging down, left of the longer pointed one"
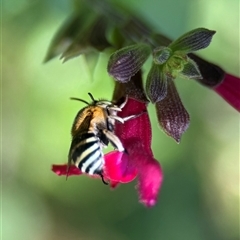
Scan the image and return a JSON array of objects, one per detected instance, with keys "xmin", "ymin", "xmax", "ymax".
[{"xmin": 146, "ymin": 64, "xmax": 168, "ymax": 103}]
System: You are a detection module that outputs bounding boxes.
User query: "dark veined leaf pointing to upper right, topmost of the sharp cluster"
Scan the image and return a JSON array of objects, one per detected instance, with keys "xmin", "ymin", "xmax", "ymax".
[{"xmin": 168, "ymin": 28, "xmax": 216, "ymax": 53}]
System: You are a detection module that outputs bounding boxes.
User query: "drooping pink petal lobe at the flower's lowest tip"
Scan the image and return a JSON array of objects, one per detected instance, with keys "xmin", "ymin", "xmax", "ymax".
[{"xmin": 138, "ymin": 158, "xmax": 163, "ymax": 207}]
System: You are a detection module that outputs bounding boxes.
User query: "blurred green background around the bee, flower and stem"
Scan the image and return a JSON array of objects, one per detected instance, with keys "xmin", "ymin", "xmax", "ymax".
[{"xmin": 1, "ymin": 0, "xmax": 240, "ymax": 240}]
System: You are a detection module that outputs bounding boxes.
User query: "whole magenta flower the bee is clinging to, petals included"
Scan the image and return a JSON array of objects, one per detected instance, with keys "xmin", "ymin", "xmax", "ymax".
[{"xmin": 52, "ymin": 99, "xmax": 163, "ymax": 207}]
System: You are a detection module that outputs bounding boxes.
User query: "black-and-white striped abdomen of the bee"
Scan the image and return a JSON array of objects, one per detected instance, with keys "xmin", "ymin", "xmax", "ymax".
[{"xmin": 69, "ymin": 132, "xmax": 104, "ymax": 174}]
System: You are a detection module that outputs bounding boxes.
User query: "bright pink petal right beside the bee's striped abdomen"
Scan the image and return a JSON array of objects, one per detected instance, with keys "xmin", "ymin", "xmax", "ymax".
[{"xmin": 104, "ymin": 151, "xmax": 137, "ymax": 183}]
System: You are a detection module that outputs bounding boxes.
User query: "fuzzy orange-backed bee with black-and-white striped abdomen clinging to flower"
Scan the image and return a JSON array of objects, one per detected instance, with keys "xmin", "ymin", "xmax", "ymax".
[{"xmin": 67, "ymin": 93, "xmax": 142, "ymax": 184}]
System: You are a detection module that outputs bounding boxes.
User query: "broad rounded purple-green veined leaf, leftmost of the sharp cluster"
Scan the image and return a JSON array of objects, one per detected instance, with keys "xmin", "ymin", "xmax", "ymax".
[{"xmin": 107, "ymin": 43, "xmax": 151, "ymax": 82}]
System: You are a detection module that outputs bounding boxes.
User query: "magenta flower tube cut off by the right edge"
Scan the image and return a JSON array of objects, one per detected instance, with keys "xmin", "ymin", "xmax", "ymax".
[{"xmin": 214, "ymin": 74, "xmax": 240, "ymax": 111}]
